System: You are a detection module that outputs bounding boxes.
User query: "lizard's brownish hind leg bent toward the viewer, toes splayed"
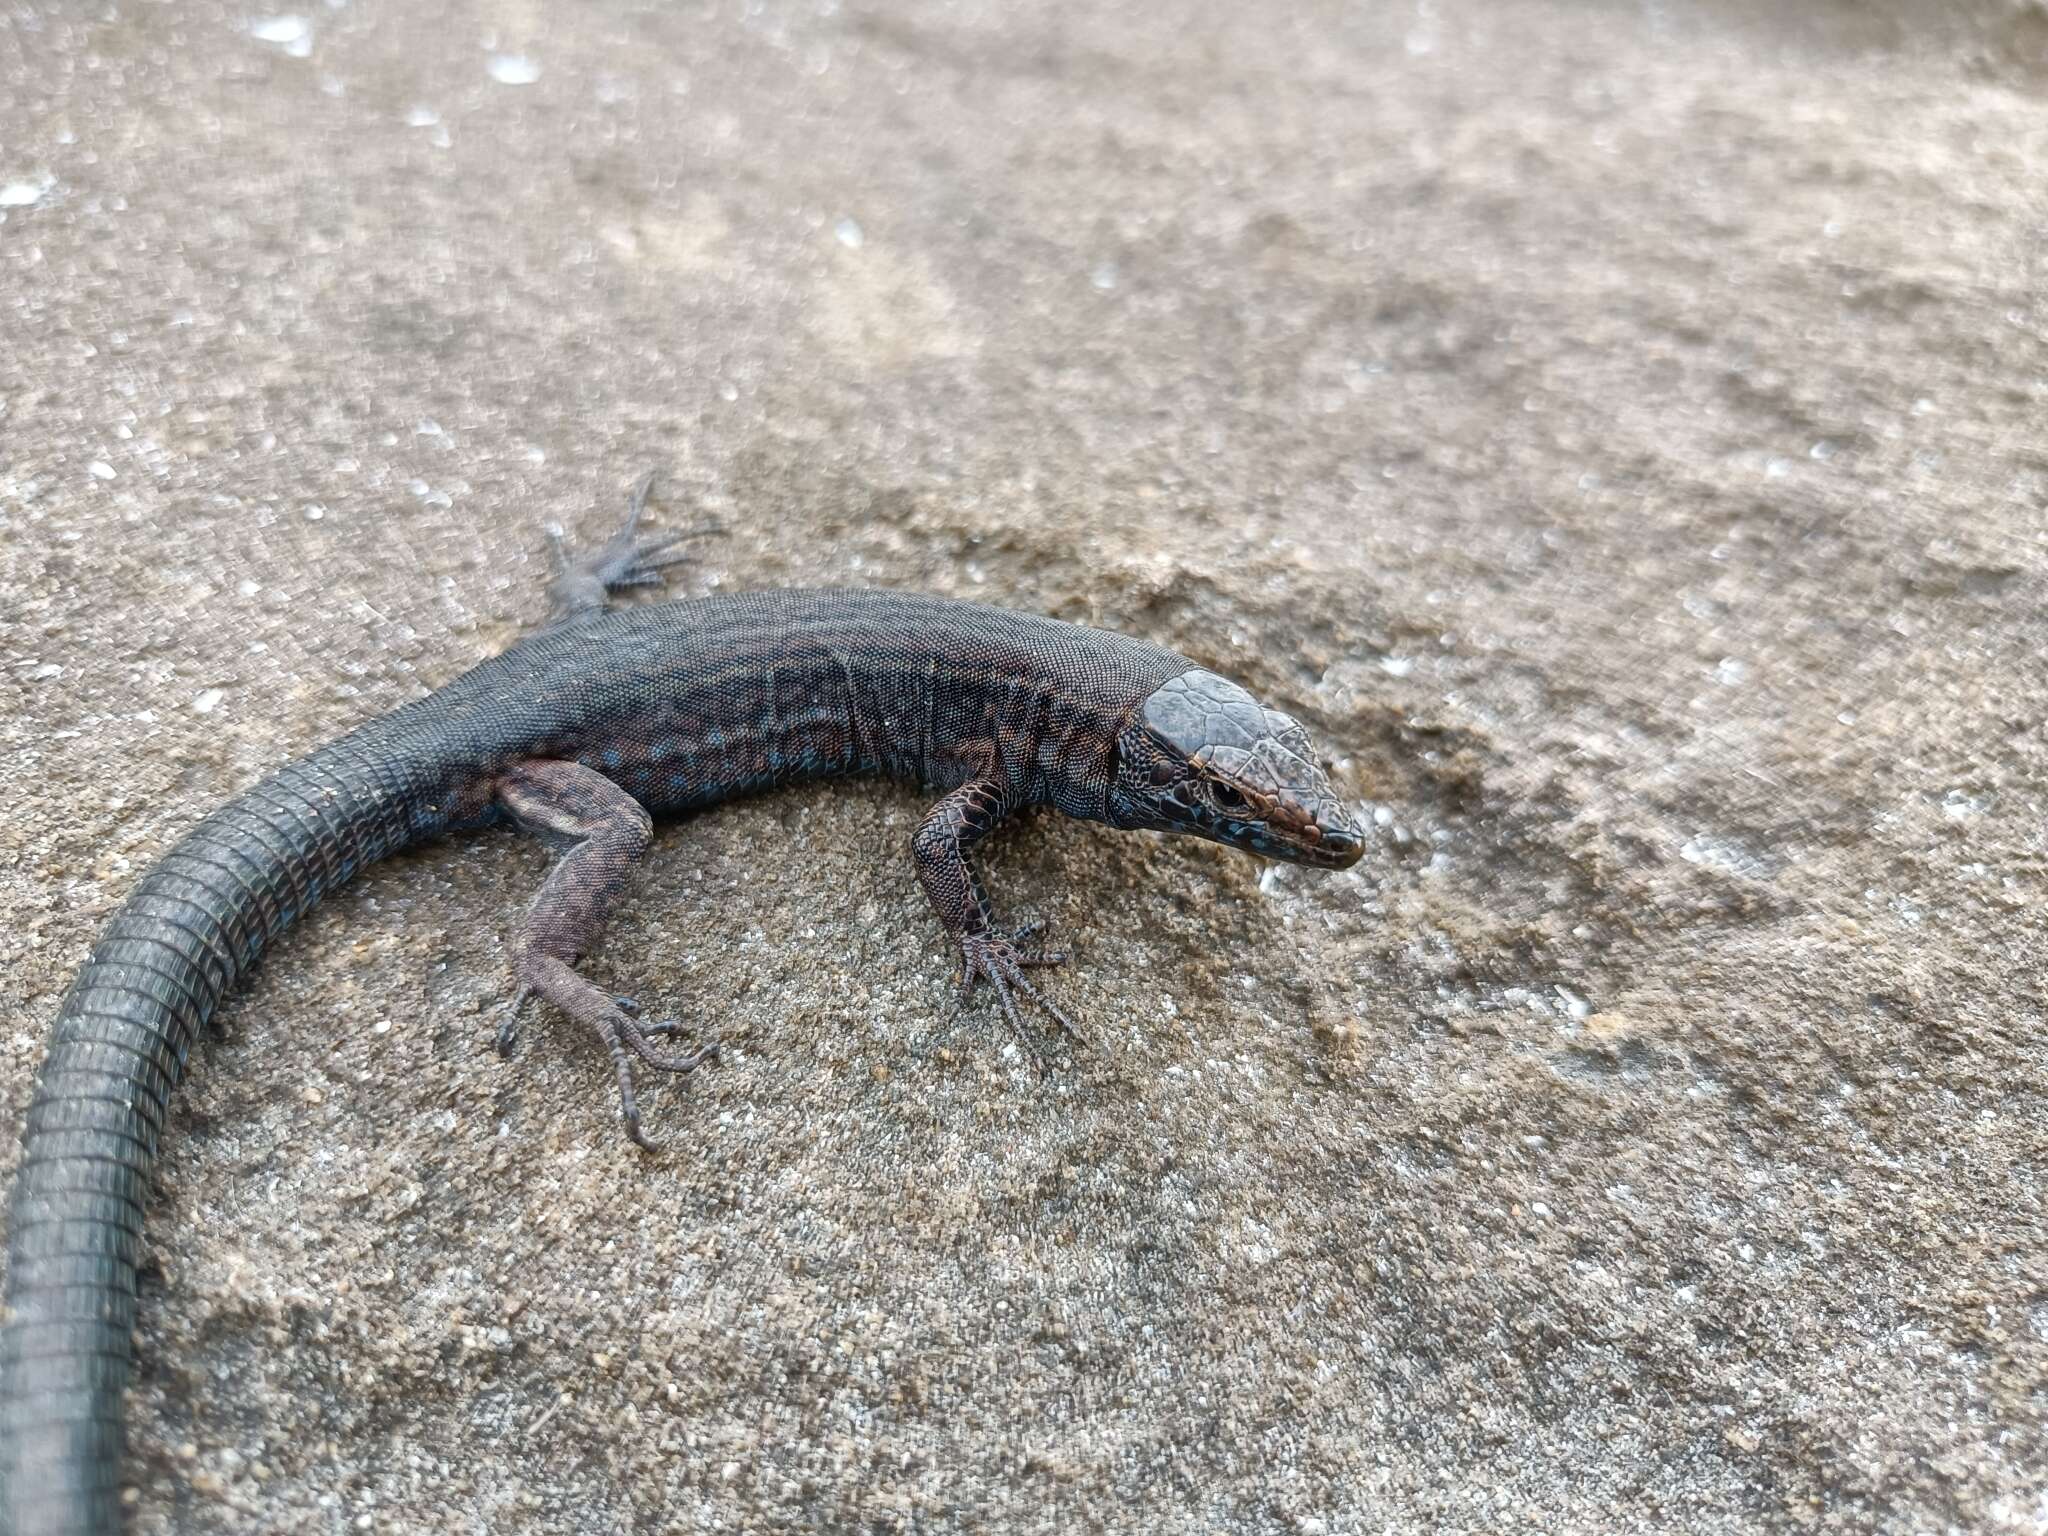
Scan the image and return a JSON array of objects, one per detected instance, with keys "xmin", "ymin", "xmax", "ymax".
[{"xmin": 498, "ymin": 760, "xmax": 719, "ymax": 1151}]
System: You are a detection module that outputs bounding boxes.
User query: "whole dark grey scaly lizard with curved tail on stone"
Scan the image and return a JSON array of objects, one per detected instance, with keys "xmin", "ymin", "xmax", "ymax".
[{"xmin": 0, "ymin": 483, "xmax": 1362, "ymax": 1536}]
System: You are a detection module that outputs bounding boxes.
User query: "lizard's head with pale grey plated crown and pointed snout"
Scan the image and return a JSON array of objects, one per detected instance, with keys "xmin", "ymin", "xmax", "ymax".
[{"xmin": 1110, "ymin": 670, "xmax": 1366, "ymax": 868}]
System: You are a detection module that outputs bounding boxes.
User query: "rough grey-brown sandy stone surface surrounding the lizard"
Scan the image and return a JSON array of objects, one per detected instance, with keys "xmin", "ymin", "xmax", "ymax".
[{"xmin": 0, "ymin": 0, "xmax": 2048, "ymax": 1532}]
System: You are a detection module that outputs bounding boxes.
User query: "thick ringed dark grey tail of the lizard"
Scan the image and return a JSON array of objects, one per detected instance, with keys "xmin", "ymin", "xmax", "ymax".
[{"xmin": 0, "ymin": 721, "xmax": 446, "ymax": 1536}]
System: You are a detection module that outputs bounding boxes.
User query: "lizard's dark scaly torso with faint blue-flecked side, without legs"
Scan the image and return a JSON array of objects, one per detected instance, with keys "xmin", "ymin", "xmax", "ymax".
[{"xmin": 416, "ymin": 588, "xmax": 1190, "ymax": 817}]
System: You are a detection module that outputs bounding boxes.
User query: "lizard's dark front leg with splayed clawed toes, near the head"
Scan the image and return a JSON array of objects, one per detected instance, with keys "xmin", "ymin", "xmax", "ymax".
[{"xmin": 909, "ymin": 778, "xmax": 1081, "ymax": 1071}]
